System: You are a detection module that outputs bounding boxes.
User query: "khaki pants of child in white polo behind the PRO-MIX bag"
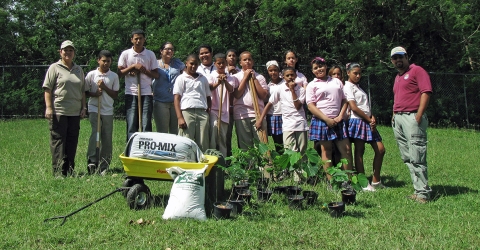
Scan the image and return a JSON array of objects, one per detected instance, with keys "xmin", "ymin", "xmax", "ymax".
[{"xmin": 178, "ymin": 109, "xmax": 210, "ymax": 152}]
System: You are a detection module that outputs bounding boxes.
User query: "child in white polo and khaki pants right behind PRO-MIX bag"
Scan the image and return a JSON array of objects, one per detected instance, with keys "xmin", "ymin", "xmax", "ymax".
[{"xmin": 173, "ymin": 54, "xmax": 212, "ymax": 152}]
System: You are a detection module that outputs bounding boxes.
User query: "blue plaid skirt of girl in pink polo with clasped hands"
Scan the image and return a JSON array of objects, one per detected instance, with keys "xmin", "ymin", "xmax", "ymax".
[{"xmin": 309, "ymin": 116, "xmax": 348, "ymax": 141}]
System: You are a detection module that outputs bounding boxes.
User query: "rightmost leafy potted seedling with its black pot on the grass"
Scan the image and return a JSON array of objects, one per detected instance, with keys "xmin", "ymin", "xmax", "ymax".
[{"xmin": 327, "ymin": 159, "xmax": 368, "ymax": 217}]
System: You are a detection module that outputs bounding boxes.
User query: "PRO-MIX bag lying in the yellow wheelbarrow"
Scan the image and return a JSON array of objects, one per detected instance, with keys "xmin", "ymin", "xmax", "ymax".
[{"xmin": 124, "ymin": 132, "xmax": 204, "ymax": 162}]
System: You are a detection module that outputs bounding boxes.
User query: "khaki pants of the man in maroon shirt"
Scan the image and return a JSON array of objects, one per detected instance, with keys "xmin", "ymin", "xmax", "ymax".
[{"xmin": 392, "ymin": 113, "xmax": 432, "ymax": 199}]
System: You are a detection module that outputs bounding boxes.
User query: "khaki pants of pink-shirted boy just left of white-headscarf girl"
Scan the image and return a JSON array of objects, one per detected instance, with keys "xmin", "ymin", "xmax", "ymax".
[{"xmin": 235, "ymin": 118, "xmax": 267, "ymax": 151}]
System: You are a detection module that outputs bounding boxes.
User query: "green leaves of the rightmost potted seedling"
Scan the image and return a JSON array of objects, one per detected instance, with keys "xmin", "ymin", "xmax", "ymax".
[{"xmin": 327, "ymin": 159, "xmax": 368, "ymax": 191}]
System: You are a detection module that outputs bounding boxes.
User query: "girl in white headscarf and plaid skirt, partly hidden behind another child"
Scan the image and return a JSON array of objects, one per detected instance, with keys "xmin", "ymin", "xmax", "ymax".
[{"xmin": 260, "ymin": 60, "xmax": 285, "ymax": 153}]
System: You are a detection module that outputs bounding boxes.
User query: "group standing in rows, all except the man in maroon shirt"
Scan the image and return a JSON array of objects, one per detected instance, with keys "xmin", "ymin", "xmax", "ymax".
[{"xmin": 43, "ymin": 30, "xmax": 385, "ymax": 191}]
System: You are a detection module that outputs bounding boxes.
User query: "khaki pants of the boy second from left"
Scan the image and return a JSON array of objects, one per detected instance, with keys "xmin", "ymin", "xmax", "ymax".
[{"xmin": 87, "ymin": 113, "xmax": 113, "ymax": 172}]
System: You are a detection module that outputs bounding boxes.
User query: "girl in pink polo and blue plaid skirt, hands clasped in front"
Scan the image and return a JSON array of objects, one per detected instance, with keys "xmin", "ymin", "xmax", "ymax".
[{"xmin": 306, "ymin": 57, "xmax": 352, "ymax": 180}]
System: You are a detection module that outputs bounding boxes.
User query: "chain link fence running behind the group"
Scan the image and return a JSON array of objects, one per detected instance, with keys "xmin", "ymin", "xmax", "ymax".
[{"xmin": 0, "ymin": 65, "xmax": 480, "ymax": 129}]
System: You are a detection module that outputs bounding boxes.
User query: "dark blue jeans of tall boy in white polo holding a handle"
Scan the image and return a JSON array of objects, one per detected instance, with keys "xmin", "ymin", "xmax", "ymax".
[{"xmin": 125, "ymin": 95, "xmax": 153, "ymax": 142}]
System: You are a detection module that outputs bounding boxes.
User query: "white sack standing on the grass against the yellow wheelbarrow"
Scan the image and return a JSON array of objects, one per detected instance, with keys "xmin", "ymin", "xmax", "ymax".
[{"xmin": 162, "ymin": 165, "xmax": 208, "ymax": 220}]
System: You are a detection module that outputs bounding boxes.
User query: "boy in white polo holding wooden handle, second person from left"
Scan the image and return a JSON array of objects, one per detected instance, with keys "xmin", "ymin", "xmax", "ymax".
[{"xmin": 85, "ymin": 50, "xmax": 120, "ymax": 174}]
